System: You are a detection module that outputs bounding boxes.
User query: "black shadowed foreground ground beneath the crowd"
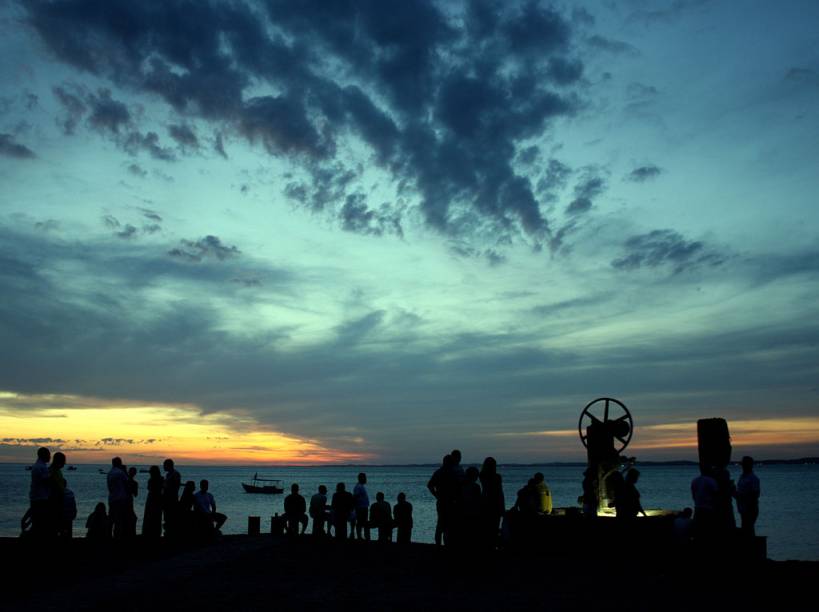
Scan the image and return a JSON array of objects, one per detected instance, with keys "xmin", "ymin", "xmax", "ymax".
[{"xmin": 0, "ymin": 535, "xmax": 819, "ymax": 612}]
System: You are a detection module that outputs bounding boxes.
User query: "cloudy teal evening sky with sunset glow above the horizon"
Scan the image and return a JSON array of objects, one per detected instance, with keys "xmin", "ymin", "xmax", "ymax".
[{"xmin": 0, "ymin": 0, "xmax": 819, "ymax": 464}]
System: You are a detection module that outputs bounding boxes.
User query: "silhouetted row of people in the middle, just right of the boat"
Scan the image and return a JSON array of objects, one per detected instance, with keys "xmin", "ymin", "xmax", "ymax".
[{"xmin": 284, "ymin": 472, "xmax": 413, "ymax": 544}]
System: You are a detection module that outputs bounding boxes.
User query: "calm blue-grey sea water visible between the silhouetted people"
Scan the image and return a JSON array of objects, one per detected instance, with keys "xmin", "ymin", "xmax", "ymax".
[{"xmin": 0, "ymin": 464, "xmax": 819, "ymax": 560}]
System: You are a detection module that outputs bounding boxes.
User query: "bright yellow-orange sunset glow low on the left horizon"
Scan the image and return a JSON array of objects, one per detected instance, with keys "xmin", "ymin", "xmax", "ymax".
[{"xmin": 0, "ymin": 393, "xmax": 369, "ymax": 465}]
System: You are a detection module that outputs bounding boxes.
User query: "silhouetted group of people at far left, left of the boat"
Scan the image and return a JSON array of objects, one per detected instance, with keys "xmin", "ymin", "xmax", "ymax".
[{"xmin": 22, "ymin": 448, "xmax": 227, "ymax": 541}]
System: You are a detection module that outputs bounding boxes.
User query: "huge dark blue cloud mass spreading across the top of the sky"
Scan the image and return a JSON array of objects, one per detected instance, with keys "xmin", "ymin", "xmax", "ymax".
[{"xmin": 26, "ymin": 0, "xmax": 583, "ymax": 249}]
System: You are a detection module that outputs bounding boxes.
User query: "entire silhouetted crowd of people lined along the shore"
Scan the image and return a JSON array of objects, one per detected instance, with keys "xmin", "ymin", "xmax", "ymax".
[{"xmin": 22, "ymin": 448, "xmax": 760, "ymax": 549}]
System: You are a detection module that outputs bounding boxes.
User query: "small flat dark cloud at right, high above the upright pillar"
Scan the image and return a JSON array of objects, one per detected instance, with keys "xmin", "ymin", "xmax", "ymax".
[{"xmin": 611, "ymin": 229, "xmax": 726, "ymax": 274}]
